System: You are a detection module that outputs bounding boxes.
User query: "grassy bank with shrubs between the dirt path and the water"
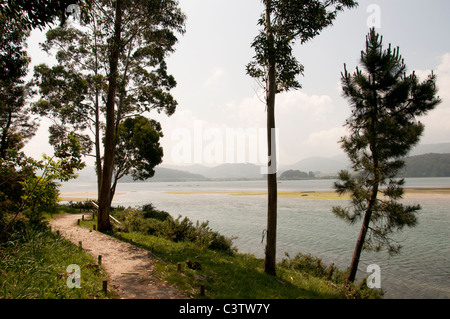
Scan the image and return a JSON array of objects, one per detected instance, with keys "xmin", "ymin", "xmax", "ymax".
[{"xmin": 78, "ymin": 207, "xmax": 381, "ymax": 299}]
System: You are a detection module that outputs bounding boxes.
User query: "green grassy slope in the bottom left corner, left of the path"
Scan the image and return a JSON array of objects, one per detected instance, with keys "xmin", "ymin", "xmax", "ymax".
[{"xmin": 0, "ymin": 208, "xmax": 115, "ymax": 299}]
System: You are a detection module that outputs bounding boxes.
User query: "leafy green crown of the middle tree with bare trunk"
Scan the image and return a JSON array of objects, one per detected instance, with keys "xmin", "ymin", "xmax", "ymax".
[{"xmin": 247, "ymin": 0, "xmax": 357, "ymax": 93}]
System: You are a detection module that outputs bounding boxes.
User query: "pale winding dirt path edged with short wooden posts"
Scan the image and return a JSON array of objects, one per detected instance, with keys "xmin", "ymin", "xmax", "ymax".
[{"xmin": 50, "ymin": 214, "xmax": 188, "ymax": 299}]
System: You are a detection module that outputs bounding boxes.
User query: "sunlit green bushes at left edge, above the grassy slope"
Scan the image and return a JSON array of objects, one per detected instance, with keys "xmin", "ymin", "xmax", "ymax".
[{"xmin": 0, "ymin": 135, "xmax": 85, "ymax": 239}]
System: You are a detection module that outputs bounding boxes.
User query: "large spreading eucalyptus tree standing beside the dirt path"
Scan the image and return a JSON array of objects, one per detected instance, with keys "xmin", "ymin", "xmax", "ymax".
[{"xmin": 35, "ymin": 0, "xmax": 185, "ymax": 230}]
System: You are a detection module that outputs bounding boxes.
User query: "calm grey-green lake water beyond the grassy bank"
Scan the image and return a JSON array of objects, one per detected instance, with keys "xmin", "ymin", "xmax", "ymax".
[{"xmin": 61, "ymin": 178, "xmax": 450, "ymax": 298}]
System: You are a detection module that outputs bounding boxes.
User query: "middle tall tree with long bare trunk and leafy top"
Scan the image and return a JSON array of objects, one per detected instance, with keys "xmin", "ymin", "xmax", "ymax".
[{"xmin": 247, "ymin": 0, "xmax": 357, "ymax": 275}]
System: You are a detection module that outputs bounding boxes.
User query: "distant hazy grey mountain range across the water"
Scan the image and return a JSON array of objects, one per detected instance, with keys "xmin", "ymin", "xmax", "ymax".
[{"xmin": 73, "ymin": 143, "xmax": 450, "ymax": 182}]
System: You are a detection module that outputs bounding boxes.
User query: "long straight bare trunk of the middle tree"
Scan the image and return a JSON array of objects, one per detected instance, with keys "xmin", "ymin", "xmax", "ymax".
[{"xmin": 264, "ymin": 1, "xmax": 277, "ymax": 275}]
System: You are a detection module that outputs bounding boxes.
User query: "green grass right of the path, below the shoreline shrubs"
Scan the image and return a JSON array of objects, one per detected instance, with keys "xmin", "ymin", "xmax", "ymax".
[{"xmin": 81, "ymin": 208, "xmax": 381, "ymax": 299}]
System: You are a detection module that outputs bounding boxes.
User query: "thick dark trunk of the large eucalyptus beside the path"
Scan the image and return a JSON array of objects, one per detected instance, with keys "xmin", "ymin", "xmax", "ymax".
[{"xmin": 98, "ymin": 0, "xmax": 122, "ymax": 231}]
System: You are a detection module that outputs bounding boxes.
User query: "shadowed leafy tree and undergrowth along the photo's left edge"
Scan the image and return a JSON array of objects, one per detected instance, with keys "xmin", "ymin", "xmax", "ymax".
[{"xmin": 0, "ymin": 0, "xmax": 84, "ymax": 240}]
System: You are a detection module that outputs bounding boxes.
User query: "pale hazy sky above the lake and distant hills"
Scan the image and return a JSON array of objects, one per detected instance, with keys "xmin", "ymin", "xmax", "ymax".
[{"xmin": 25, "ymin": 0, "xmax": 450, "ymax": 168}]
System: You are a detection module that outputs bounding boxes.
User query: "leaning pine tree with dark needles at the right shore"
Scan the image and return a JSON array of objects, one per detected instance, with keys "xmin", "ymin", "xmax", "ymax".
[{"xmin": 333, "ymin": 29, "xmax": 440, "ymax": 282}]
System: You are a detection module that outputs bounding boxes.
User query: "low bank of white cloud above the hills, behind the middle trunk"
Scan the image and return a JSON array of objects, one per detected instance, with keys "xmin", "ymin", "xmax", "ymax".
[{"xmin": 156, "ymin": 91, "xmax": 344, "ymax": 164}]
